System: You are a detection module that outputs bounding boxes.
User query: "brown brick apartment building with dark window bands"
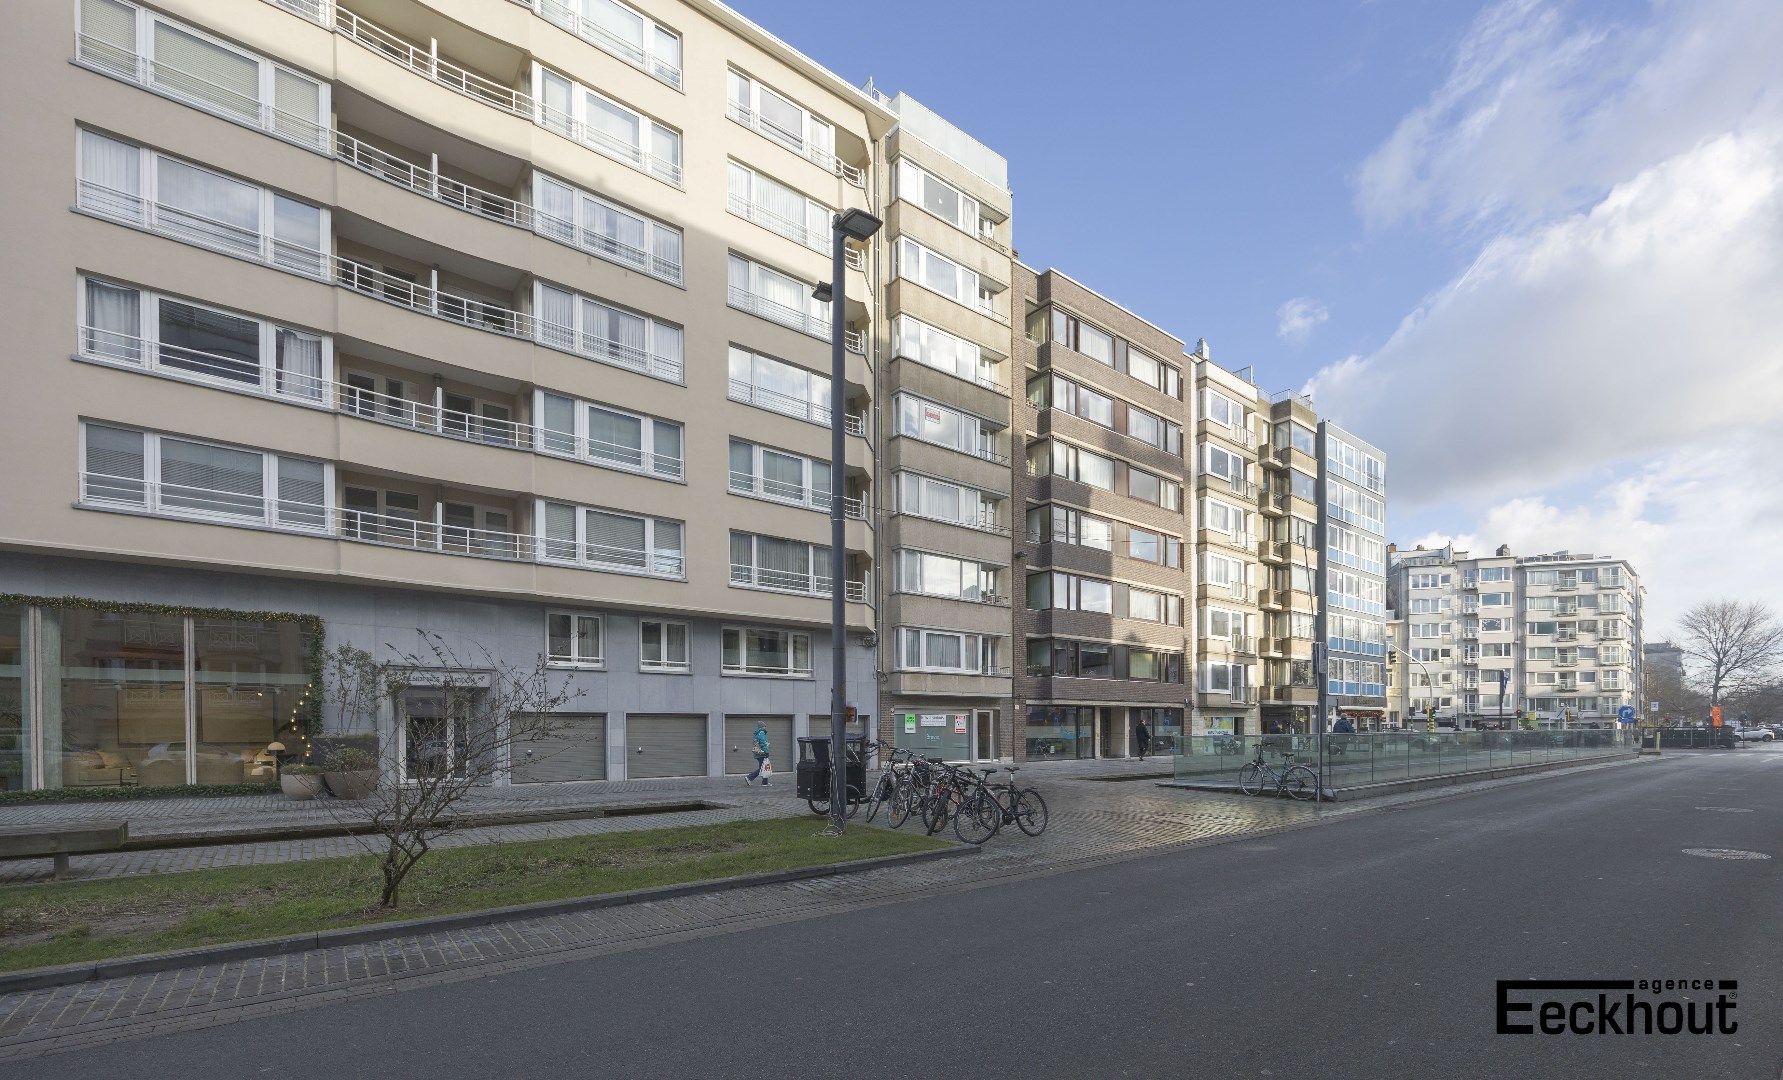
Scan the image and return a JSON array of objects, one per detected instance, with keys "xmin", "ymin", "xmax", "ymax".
[{"xmin": 1011, "ymin": 264, "xmax": 1198, "ymax": 759}]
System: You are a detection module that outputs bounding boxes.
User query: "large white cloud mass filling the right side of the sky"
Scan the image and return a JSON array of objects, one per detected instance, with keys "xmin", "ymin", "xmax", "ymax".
[{"xmin": 1307, "ymin": 0, "xmax": 1783, "ymax": 631}]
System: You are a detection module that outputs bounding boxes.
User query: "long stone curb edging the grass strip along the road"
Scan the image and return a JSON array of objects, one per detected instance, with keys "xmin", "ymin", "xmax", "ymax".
[{"xmin": 0, "ymin": 843, "xmax": 981, "ymax": 994}]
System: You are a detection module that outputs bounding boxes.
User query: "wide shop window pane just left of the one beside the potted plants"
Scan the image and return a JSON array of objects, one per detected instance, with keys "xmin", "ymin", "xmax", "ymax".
[{"xmin": 37, "ymin": 608, "xmax": 186, "ymax": 788}]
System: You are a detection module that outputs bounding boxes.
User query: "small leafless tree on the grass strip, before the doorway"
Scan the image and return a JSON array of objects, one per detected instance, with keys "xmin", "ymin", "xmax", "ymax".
[{"xmin": 323, "ymin": 631, "xmax": 579, "ymax": 907}]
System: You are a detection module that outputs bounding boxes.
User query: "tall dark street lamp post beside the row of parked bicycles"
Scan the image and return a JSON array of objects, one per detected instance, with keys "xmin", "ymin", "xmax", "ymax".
[{"xmin": 813, "ymin": 210, "xmax": 881, "ymax": 836}]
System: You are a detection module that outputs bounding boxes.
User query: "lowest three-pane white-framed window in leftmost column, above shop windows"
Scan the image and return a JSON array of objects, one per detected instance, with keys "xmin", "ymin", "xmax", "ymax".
[{"xmin": 80, "ymin": 424, "xmax": 330, "ymax": 531}]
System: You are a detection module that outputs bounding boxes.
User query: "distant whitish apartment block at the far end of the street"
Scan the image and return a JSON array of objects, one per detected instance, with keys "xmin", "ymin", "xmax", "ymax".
[{"xmin": 1387, "ymin": 545, "xmax": 1644, "ymax": 727}]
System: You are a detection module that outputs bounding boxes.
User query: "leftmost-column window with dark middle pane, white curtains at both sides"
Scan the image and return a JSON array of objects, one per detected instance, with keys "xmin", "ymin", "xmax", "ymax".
[{"xmin": 80, "ymin": 278, "xmax": 333, "ymax": 401}]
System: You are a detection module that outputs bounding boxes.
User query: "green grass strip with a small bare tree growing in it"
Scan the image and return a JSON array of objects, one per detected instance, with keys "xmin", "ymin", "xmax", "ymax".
[{"xmin": 0, "ymin": 814, "xmax": 947, "ymax": 971}]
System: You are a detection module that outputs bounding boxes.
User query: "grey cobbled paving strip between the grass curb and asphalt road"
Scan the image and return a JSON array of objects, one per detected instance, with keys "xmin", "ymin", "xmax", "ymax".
[{"xmin": 0, "ymin": 763, "xmax": 1633, "ymax": 1060}]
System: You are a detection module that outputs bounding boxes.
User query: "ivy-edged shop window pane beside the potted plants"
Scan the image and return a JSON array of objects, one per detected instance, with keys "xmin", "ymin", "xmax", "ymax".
[{"xmin": 193, "ymin": 618, "xmax": 308, "ymax": 784}]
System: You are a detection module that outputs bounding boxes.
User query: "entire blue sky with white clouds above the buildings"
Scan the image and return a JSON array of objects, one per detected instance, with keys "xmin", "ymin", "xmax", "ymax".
[{"xmin": 736, "ymin": 0, "xmax": 1783, "ymax": 636}]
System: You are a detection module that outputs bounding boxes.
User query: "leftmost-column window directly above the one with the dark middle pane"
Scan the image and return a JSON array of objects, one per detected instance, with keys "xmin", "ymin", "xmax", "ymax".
[{"xmin": 78, "ymin": 130, "xmax": 328, "ymax": 276}]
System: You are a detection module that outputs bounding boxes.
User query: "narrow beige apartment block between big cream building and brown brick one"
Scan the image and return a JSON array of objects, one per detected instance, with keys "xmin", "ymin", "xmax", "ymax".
[{"xmin": 874, "ymin": 94, "xmax": 1020, "ymax": 761}]
